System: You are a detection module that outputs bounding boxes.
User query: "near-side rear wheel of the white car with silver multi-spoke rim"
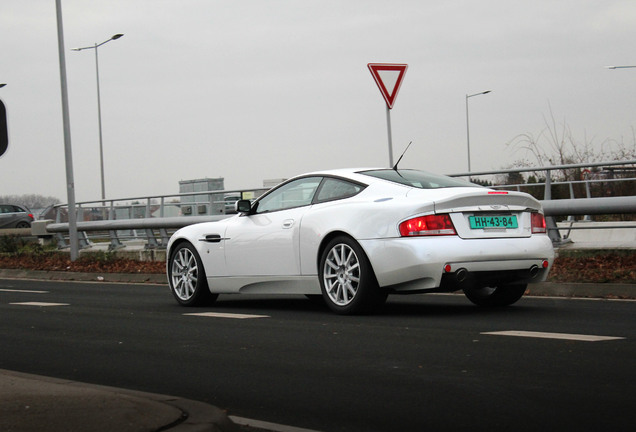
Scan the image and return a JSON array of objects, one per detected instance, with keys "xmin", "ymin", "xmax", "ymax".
[{"xmin": 319, "ymin": 236, "xmax": 387, "ymax": 315}]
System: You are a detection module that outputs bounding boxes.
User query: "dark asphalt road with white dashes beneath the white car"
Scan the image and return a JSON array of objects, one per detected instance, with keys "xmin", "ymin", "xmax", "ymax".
[{"xmin": 0, "ymin": 280, "xmax": 636, "ymax": 432}]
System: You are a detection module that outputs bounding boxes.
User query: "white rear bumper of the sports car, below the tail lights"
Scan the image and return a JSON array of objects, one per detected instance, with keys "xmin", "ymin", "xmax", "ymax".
[{"xmin": 360, "ymin": 235, "xmax": 554, "ymax": 292}]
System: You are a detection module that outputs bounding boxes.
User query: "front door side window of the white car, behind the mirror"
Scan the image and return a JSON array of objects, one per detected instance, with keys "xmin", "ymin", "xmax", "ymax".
[{"xmin": 256, "ymin": 177, "xmax": 322, "ymax": 213}]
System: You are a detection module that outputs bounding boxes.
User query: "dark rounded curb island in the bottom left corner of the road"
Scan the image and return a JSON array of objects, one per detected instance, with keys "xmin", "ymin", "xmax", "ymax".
[{"xmin": 0, "ymin": 369, "xmax": 244, "ymax": 432}]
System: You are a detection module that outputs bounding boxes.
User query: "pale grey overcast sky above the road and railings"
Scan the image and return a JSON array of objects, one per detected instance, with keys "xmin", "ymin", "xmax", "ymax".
[{"xmin": 0, "ymin": 0, "xmax": 636, "ymax": 202}]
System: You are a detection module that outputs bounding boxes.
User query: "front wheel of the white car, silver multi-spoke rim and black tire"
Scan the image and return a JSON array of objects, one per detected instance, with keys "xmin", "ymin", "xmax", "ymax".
[{"xmin": 168, "ymin": 243, "xmax": 218, "ymax": 306}]
